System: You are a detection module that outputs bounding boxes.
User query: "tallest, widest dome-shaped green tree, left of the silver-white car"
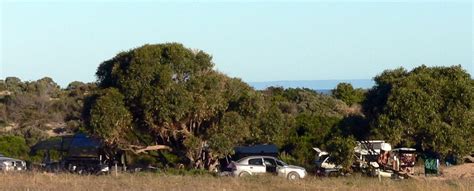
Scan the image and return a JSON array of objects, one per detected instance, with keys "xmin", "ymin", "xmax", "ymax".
[{"xmin": 92, "ymin": 43, "xmax": 259, "ymax": 169}]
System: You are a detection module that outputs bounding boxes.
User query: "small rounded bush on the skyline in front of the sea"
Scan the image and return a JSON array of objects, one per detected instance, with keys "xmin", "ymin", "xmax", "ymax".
[{"xmin": 332, "ymin": 83, "xmax": 364, "ymax": 106}]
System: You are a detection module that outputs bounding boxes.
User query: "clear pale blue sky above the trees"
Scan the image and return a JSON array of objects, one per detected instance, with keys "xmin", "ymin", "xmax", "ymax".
[{"xmin": 0, "ymin": 0, "xmax": 474, "ymax": 87}]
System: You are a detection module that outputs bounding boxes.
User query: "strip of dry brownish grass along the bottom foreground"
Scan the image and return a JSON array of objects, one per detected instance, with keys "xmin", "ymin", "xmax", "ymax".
[{"xmin": 0, "ymin": 173, "xmax": 474, "ymax": 191}]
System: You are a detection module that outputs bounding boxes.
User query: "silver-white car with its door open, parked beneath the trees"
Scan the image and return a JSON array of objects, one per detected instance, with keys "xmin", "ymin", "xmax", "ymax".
[{"xmin": 229, "ymin": 156, "xmax": 308, "ymax": 180}]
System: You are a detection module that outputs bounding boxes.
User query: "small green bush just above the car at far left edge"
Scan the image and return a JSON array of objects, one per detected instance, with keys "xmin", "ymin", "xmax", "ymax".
[{"xmin": 0, "ymin": 135, "xmax": 30, "ymax": 160}]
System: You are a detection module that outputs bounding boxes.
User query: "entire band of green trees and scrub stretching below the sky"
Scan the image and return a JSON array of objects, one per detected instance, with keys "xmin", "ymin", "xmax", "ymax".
[{"xmin": 0, "ymin": 43, "xmax": 474, "ymax": 172}]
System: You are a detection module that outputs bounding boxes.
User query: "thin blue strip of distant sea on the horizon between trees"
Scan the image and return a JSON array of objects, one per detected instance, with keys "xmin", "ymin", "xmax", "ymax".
[{"xmin": 248, "ymin": 79, "xmax": 375, "ymax": 94}]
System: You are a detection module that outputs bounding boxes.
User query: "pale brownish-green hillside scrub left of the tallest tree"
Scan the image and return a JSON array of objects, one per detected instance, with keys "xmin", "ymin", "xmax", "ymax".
[{"xmin": 0, "ymin": 77, "xmax": 92, "ymax": 145}]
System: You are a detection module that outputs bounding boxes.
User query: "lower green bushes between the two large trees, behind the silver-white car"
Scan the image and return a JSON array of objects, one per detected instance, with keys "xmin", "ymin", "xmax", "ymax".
[{"xmin": 255, "ymin": 87, "xmax": 358, "ymax": 168}]
